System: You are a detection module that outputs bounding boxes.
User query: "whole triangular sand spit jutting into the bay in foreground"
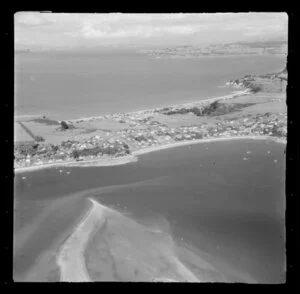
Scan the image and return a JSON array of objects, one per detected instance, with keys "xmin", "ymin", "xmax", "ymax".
[{"xmin": 57, "ymin": 199, "xmax": 224, "ymax": 282}]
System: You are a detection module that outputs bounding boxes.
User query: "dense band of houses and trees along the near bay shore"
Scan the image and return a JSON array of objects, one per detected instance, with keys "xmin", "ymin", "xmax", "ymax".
[{"xmin": 15, "ymin": 109, "xmax": 287, "ymax": 167}]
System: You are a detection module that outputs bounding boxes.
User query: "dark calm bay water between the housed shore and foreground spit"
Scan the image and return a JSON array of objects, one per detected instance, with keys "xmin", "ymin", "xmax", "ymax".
[{"xmin": 14, "ymin": 140, "xmax": 285, "ymax": 283}]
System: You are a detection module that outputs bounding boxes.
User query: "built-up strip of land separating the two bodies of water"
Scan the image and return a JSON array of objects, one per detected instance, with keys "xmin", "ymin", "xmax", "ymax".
[{"xmin": 14, "ymin": 68, "xmax": 287, "ymax": 172}]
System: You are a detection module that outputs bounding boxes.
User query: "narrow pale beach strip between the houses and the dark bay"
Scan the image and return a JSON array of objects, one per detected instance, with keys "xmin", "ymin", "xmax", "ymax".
[{"xmin": 14, "ymin": 136, "xmax": 286, "ymax": 174}]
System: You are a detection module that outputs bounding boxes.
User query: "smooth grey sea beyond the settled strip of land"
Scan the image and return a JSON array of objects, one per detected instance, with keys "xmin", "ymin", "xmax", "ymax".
[{"xmin": 15, "ymin": 51, "xmax": 286, "ymax": 120}]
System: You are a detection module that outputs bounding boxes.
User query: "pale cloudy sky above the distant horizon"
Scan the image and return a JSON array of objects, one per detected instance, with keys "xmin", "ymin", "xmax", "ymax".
[{"xmin": 14, "ymin": 12, "xmax": 288, "ymax": 50}]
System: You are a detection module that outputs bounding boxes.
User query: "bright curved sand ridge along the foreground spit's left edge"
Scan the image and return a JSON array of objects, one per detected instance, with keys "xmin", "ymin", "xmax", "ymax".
[{"xmin": 57, "ymin": 199, "xmax": 103, "ymax": 282}]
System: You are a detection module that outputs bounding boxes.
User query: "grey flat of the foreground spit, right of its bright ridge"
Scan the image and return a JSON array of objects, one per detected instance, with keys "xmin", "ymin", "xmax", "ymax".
[{"xmin": 85, "ymin": 201, "xmax": 200, "ymax": 282}]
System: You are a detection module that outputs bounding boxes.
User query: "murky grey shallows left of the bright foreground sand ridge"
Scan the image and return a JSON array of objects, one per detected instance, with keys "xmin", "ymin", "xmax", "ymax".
[{"xmin": 13, "ymin": 193, "xmax": 89, "ymax": 282}]
